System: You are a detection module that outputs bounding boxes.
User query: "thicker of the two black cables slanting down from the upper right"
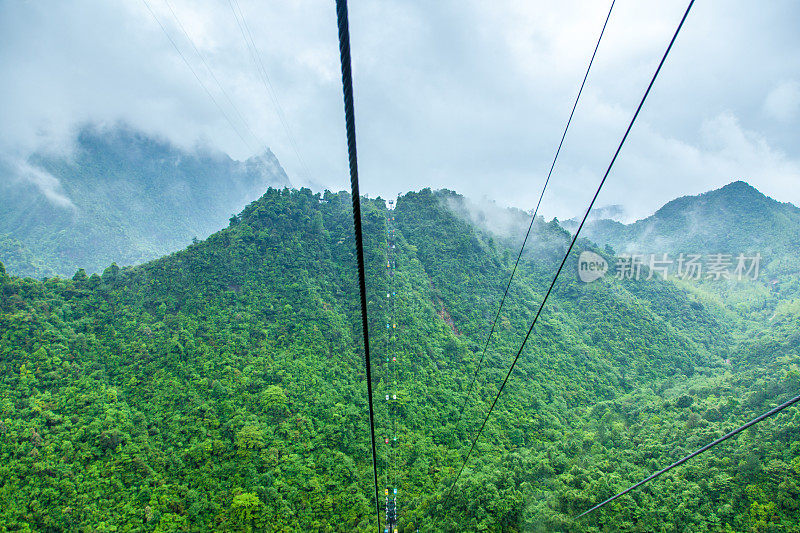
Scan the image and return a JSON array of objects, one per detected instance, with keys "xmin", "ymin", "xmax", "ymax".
[{"xmin": 445, "ymin": 0, "xmax": 694, "ymax": 508}]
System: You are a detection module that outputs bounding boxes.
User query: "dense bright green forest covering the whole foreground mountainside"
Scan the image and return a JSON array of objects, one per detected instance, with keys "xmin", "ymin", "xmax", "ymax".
[{"xmin": 0, "ymin": 188, "xmax": 800, "ymax": 532}]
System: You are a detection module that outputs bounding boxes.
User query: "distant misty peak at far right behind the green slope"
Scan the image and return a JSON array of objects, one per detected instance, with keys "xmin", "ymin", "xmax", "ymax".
[{"xmin": 562, "ymin": 181, "xmax": 800, "ymax": 320}]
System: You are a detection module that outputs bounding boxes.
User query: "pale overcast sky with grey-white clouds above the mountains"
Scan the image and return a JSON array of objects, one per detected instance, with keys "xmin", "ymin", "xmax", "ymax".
[{"xmin": 0, "ymin": 0, "xmax": 800, "ymax": 219}]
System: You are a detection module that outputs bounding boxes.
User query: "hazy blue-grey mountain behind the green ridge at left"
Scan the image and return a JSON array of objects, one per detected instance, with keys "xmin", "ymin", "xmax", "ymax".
[{"xmin": 0, "ymin": 125, "xmax": 289, "ymax": 278}]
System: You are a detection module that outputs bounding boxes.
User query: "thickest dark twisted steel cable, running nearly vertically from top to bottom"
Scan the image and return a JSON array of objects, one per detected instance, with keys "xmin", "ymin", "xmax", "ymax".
[{"xmin": 336, "ymin": 0, "xmax": 381, "ymax": 532}]
